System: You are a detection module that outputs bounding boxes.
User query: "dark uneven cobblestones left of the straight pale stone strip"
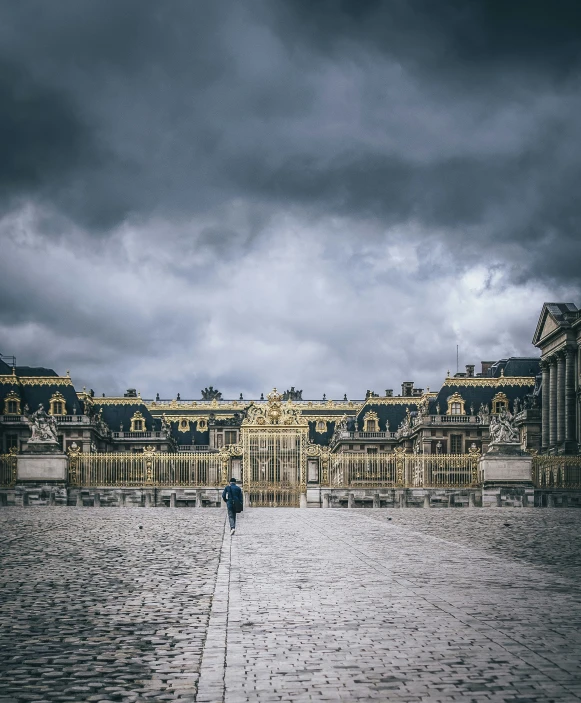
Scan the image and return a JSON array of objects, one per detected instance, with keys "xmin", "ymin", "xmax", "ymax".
[{"xmin": 0, "ymin": 508, "xmax": 224, "ymax": 703}]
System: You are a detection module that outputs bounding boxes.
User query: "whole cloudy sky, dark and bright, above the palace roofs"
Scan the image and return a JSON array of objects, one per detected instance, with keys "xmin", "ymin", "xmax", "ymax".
[{"xmin": 0, "ymin": 0, "xmax": 581, "ymax": 398}]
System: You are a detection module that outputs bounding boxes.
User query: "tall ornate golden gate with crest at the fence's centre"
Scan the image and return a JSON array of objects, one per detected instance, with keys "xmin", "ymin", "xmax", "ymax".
[{"xmin": 241, "ymin": 388, "xmax": 309, "ymax": 507}]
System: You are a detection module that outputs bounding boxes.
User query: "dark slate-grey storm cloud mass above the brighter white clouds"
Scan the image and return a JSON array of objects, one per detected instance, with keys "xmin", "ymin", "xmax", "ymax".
[{"xmin": 0, "ymin": 0, "xmax": 581, "ymax": 278}]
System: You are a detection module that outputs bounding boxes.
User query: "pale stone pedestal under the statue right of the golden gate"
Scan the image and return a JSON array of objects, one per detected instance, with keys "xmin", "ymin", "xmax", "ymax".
[{"xmin": 478, "ymin": 442, "xmax": 534, "ymax": 507}]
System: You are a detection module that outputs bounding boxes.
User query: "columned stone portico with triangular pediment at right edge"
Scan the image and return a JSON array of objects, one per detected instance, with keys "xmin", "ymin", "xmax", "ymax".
[{"xmin": 533, "ymin": 303, "xmax": 581, "ymax": 454}]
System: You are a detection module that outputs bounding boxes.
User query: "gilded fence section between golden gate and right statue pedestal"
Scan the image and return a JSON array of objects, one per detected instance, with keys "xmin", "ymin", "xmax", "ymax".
[{"xmin": 329, "ymin": 450, "xmax": 480, "ymax": 488}]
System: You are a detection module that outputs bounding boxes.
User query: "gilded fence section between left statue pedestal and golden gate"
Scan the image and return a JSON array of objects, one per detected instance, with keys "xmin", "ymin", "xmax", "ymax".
[{"xmin": 69, "ymin": 450, "xmax": 228, "ymax": 487}]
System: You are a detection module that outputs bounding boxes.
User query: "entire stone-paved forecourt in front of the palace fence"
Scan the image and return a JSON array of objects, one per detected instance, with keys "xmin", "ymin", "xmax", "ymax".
[{"xmin": 0, "ymin": 508, "xmax": 581, "ymax": 703}]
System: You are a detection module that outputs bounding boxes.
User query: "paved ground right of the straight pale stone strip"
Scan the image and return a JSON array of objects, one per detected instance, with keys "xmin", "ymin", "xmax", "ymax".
[{"xmin": 226, "ymin": 509, "xmax": 581, "ymax": 702}]
